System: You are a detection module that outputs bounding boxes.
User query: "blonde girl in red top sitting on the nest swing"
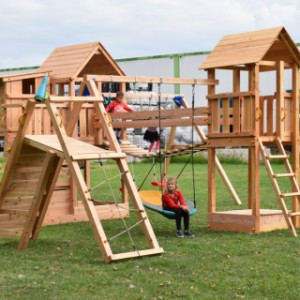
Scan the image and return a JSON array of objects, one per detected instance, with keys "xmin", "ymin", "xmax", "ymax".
[{"xmin": 162, "ymin": 178, "xmax": 194, "ymax": 238}]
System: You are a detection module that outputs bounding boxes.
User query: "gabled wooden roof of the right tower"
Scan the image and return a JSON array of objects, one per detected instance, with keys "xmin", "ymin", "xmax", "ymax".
[{"xmin": 200, "ymin": 27, "xmax": 300, "ymax": 69}]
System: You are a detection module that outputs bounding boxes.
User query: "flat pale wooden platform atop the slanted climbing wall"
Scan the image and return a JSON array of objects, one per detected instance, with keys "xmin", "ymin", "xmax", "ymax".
[{"xmin": 24, "ymin": 135, "xmax": 125, "ymax": 160}]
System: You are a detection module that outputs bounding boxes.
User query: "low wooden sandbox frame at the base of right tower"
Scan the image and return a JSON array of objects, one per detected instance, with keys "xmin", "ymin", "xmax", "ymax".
[{"xmin": 208, "ymin": 209, "xmax": 288, "ymax": 233}]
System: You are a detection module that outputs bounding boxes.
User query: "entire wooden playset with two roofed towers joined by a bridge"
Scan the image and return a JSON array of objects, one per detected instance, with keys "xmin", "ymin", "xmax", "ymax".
[{"xmin": 0, "ymin": 28, "xmax": 300, "ymax": 262}]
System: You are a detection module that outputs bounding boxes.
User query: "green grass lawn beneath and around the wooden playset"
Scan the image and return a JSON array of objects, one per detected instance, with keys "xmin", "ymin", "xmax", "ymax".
[{"xmin": 0, "ymin": 158, "xmax": 300, "ymax": 299}]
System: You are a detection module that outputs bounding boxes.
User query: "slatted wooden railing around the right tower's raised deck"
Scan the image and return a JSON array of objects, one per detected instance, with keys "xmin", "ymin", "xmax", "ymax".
[{"xmin": 207, "ymin": 92, "xmax": 293, "ymax": 141}]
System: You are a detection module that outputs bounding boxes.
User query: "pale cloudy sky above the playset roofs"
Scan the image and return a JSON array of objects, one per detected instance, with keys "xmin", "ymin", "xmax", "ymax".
[{"xmin": 0, "ymin": 0, "xmax": 300, "ymax": 69}]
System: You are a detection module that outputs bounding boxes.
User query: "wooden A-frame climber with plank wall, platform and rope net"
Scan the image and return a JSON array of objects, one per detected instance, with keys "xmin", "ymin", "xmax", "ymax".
[{"xmin": 0, "ymin": 80, "xmax": 163, "ymax": 262}]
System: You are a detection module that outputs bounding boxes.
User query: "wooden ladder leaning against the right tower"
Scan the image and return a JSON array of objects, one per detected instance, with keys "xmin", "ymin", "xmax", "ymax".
[{"xmin": 259, "ymin": 137, "xmax": 300, "ymax": 237}]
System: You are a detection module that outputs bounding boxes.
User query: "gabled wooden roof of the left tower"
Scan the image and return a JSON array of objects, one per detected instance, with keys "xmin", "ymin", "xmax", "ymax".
[{"xmin": 38, "ymin": 42, "xmax": 125, "ymax": 80}]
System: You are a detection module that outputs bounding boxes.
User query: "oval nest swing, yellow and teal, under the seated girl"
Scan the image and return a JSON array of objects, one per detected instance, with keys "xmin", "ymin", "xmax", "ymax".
[{"xmin": 139, "ymin": 190, "xmax": 197, "ymax": 219}]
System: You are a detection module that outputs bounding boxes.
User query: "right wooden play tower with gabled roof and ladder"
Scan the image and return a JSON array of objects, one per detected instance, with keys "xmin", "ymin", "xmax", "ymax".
[{"xmin": 200, "ymin": 27, "xmax": 300, "ymax": 236}]
